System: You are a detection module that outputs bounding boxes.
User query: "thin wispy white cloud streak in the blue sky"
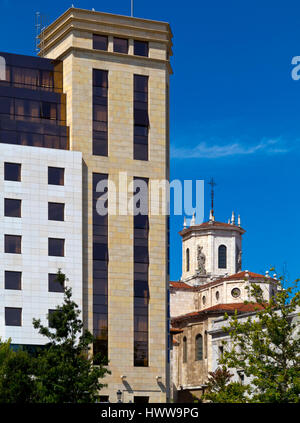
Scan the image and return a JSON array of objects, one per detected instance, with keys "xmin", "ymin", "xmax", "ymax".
[{"xmin": 171, "ymin": 139, "xmax": 288, "ymax": 159}]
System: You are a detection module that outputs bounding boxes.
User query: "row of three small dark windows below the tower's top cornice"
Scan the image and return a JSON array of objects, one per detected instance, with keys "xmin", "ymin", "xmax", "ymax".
[{"xmin": 93, "ymin": 34, "xmax": 149, "ymax": 57}]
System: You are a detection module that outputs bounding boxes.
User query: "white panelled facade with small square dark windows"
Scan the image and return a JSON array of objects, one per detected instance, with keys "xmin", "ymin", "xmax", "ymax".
[{"xmin": 0, "ymin": 144, "xmax": 82, "ymax": 345}]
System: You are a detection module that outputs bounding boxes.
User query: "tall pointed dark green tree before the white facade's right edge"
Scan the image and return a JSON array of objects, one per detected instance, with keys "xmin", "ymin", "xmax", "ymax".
[{"xmin": 33, "ymin": 271, "xmax": 110, "ymax": 403}]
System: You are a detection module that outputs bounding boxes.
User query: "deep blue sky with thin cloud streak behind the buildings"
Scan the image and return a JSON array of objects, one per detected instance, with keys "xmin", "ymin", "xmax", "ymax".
[{"xmin": 0, "ymin": 0, "xmax": 300, "ymax": 280}]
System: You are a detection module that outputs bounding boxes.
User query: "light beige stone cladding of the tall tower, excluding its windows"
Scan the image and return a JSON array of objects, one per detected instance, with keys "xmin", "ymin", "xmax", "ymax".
[{"xmin": 40, "ymin": 8, "xmax": 172, "ymax": 402}]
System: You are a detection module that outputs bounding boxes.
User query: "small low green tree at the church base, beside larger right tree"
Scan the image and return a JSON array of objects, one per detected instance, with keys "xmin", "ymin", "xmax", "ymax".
[{"xmin": 204, "ymin": 366, "xmax": 249, "ymax": 403}]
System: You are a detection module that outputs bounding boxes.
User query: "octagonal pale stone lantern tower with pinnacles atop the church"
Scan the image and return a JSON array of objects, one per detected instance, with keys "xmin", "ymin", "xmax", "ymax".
[{"xmin": 180, "ymin": 212, "xmax": 245, "ymax": 286}]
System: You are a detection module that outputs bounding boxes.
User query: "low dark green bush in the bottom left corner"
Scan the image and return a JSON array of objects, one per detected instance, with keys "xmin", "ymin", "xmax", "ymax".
[{"xmin": 0, "ymin": 339, "xmax": 36, "ymax": 403}]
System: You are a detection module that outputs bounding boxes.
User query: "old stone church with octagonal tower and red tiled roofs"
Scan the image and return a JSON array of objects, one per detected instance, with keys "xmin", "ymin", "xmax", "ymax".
[{"xmin": 170, "ymin": 202, "xmax": 278, "ymax": 402}]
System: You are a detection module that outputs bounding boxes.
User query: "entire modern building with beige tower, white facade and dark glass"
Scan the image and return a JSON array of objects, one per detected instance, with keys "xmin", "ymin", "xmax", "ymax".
[{"xmin": 0, "ymin": 8, "xmax": 172, "ymax": 402}]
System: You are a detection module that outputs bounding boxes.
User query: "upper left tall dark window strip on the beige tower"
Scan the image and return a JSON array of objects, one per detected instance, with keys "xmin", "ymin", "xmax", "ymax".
[{"xmin": 93, "ymin": 69, "xmax": 108, "ymax": 156}]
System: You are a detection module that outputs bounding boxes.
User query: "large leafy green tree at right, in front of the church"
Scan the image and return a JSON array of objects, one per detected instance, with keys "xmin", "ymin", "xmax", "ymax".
[{"xmin": 220, "ymin": 278, "xmax": 300, "ymax": 403}]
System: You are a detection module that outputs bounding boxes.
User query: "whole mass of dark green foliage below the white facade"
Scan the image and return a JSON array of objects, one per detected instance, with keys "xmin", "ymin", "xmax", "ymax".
[{"xmin": 0, "ymin": 271, "xmax": 110, "ymax": 403}]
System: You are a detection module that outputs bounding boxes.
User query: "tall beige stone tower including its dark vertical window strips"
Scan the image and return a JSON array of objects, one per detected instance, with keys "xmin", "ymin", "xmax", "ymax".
[{"xmin": 40, "ymin": 7, "xmax": 172, "ymax": 402}]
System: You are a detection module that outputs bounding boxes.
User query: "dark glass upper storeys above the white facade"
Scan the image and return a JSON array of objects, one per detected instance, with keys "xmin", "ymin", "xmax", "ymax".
[{"xmin": 0, "ymin": 53, "xmax": 69, "ymax": 149}]
